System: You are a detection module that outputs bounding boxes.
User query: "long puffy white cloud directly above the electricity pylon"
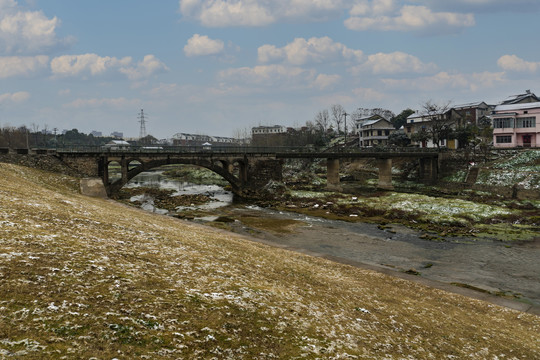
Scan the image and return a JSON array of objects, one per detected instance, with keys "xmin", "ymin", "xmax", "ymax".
[{"xmin": 51, "ymin": 54, "xmax": 167, "ymax": 80}]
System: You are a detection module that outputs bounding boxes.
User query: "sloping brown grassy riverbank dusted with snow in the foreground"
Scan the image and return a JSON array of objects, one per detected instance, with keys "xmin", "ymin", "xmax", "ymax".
[{"xmin": 0, "ymin": 163, "xmax": 540, "ymax": 359}]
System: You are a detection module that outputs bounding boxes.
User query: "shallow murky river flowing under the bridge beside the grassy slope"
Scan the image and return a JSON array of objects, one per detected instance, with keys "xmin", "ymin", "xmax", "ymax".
[{"xmin": 127, "ymin": 171, "xmax": 540, "ymax": 306}]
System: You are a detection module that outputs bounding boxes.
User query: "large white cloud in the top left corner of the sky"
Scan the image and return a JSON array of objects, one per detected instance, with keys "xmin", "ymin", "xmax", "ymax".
[{"xmin": 0, "ymin": 0, "xmax": 71, "ymax": 54}]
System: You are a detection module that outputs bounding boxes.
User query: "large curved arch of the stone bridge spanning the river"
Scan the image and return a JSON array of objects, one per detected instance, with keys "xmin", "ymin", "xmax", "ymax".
[{"xmin": 107, "ymin": 158, "xmax": 244, "ymax": 195}]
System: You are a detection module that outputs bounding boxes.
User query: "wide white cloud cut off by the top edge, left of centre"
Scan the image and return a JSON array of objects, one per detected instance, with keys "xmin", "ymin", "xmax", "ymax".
[{"xmin": 180, "ymin": 0, "xmax": 349, "ymax": 27}]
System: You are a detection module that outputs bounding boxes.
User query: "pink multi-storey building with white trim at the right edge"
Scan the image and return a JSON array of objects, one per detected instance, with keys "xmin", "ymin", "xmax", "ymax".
[{"xmin": 492, "ymin": 102, "xmax": 540, "ymax": 147}]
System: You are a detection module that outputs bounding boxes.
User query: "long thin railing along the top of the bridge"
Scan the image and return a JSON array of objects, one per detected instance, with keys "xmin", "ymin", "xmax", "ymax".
[{"xmin": 55, "ymin": 145, "xmax": 445, "ymax": 154}]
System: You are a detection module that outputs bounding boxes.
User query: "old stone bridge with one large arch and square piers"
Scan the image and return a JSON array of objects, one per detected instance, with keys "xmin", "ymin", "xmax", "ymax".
[{"xmin": 55, "ymin": 147, "xmax": 440, "ymax": 196}]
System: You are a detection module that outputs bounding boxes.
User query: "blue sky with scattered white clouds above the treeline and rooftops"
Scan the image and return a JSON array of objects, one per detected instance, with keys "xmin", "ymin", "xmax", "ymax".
[{"xmin": 0, "ymin": 0, "xmax": 540, "ymax": 138}]
